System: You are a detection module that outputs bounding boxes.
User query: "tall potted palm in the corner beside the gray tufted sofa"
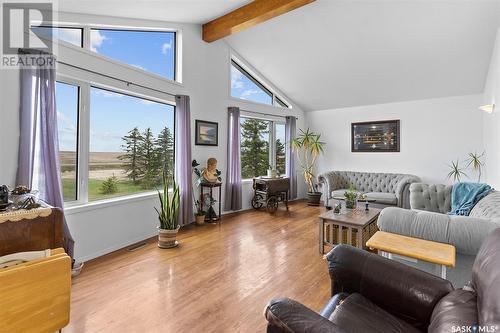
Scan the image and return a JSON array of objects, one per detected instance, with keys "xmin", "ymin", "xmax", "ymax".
[{"xmin": 291, "ymin": 128, "xmax": 325, "ymax": 206}]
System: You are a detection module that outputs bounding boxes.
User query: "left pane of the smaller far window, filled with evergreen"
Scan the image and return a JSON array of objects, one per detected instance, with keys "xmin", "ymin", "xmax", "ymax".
[{"xmin": 241, "ymin": 118, "xmax": 269, "ymax": 179}]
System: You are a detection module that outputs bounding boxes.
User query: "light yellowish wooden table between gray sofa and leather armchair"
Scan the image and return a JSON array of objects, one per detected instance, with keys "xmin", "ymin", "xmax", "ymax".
[{"xmin": 366, "ymin": 231, "xmax": 455, "ymax": 279}]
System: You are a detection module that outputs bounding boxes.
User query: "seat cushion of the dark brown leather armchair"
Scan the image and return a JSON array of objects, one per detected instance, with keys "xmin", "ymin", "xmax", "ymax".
[{"xmin": 329, "ymin": 293, "xmax": 420, "ymax": 333}]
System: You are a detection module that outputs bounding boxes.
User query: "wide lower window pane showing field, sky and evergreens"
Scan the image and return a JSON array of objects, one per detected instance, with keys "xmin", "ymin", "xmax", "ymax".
[{"xmin": 88, "ymin": 87, "xmax": 174, "ymax": 201}]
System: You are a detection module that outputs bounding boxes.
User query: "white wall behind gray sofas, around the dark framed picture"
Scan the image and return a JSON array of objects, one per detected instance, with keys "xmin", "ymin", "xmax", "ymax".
[{"xmin": 308, "ymin": 95, "xmax": 483, "ymax": 183}]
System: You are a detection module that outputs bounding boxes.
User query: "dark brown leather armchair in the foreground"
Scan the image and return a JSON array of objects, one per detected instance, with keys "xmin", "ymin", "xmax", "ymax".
[{"xmin": 265, "ymin": 228, "xmax": 500, "ymax": 333}]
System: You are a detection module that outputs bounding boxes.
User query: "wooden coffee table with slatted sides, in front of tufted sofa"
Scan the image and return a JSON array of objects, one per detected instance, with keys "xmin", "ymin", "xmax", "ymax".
[{"xmin": 318, "ymin": 208, "xmax": 381, "ymax": 254}]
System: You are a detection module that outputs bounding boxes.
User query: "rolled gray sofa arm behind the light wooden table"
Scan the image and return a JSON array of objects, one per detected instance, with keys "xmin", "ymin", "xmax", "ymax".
[{"xmin": 377, "ymin": 207, "xmax": 500, "ymax": 255}]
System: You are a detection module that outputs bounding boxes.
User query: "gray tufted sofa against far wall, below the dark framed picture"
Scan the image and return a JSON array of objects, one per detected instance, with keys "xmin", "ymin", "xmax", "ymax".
[{"xmin": 318, "ymin": 171, "xmax": 420, "ymax": 208}]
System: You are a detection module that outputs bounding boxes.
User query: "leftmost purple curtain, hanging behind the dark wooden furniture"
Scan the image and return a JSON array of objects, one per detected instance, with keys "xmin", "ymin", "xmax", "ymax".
[{"xmin": 16, "ymin": 50, "xmax": 75, "ymax": 258}]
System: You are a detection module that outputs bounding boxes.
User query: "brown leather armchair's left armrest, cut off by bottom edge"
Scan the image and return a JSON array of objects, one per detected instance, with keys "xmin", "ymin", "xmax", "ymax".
[{"xmin": 264, "ymin": 298, "xmax": 345, "ymax": 333}]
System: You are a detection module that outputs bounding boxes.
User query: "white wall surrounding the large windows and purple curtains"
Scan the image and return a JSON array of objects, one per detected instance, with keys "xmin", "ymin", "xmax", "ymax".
[{"xmin": 0, "ymin": 13, "xmax": 305, "ymax": 260}]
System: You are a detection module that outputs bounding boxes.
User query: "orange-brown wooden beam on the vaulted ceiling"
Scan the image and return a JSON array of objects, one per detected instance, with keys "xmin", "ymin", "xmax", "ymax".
[{"xmin": 203, "ymin": 0, "xmax": 315, "ymax": 43}]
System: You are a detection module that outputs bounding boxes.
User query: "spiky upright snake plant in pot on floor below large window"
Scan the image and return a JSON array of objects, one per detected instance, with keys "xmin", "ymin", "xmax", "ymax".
[{"xmin": 155, "ymin": 170, "xmax": 180, "ymax": 249}]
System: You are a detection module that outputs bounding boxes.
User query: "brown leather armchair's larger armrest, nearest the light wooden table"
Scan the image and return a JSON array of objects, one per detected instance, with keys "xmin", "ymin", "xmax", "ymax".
[{"xmin": 327, "ymin": 245, "xmax": 453, "ymax": 329}]
